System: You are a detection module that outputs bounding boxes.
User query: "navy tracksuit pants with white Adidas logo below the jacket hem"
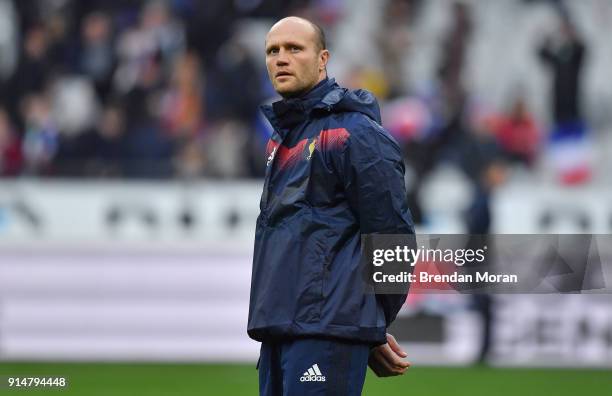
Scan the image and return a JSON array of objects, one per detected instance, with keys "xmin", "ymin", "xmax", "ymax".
[{"xmin": 258, "ymin": 338, "xmax": 370, "ymax": 396}]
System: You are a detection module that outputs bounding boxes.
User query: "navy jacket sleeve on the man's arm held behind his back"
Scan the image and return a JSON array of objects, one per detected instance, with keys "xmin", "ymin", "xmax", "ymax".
[{"xmin": 343, "ymin": 125, "xmax": 414, "ymax": 327}]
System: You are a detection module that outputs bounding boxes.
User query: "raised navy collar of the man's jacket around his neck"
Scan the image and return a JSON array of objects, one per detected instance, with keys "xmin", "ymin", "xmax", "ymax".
[{"xmin": 261, "ymin": 78, "xmax": 342, "ymax": 138}]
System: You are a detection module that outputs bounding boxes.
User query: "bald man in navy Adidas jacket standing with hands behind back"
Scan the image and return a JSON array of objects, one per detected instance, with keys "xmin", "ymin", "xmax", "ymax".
[{"xmin": 248, "ymin": 17, "xmax": 414, "ymax": 396}]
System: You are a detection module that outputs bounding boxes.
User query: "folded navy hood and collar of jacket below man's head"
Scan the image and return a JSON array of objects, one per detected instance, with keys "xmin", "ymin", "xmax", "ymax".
[{"xmin": 261, "ymin": 78, "xmax": 381, "ymax": 136}]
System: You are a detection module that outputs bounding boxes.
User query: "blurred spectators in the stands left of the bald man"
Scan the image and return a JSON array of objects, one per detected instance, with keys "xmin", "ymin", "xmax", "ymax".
[{"xmin": 0, "ymin": 0, "xmax": 310, "ymax": 178}]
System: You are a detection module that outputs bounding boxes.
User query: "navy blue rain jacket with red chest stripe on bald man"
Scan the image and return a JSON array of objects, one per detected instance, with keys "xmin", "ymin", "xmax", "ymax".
[{"xmin": 248, "ymin": 79, "xmax": 414, "ymax": 344}]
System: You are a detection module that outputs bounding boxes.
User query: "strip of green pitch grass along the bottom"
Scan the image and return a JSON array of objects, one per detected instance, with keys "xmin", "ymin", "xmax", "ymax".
[{"xmin": 0, "ymin": 363, "xmax": 612, "ymax": 396}]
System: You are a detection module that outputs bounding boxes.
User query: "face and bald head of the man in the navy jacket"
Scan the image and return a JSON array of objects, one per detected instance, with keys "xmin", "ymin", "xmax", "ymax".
[{"xmin": 266, "ymin": 18, "xmax": 329, "ymax": 98}]
